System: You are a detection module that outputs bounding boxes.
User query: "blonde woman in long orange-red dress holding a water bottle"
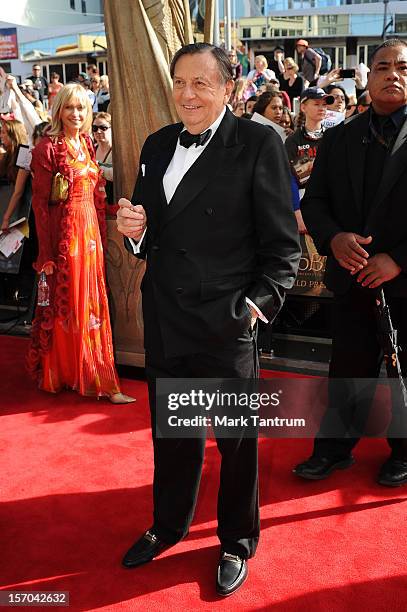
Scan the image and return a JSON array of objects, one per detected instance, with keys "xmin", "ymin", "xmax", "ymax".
[{"xmin": 28, "ymin": 84, "xmax": 134, "ymax": 403}]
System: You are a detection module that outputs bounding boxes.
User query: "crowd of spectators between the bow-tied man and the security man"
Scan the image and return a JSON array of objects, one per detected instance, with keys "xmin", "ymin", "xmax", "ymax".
[{"xmin": 229, "ymin": 39, "xmax": 371, "ymax": 233}]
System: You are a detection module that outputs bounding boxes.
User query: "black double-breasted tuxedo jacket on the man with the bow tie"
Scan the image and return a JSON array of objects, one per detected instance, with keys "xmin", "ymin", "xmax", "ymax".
[{"xmin": 125, "ymin": 110, "xmax": 300, "ymax": 357}]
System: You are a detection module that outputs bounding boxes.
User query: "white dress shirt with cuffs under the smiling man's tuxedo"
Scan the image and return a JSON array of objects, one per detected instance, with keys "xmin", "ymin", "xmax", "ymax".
[{"xmin": 128, "ymin": 106, "xmax": 268, "ymax": 323}]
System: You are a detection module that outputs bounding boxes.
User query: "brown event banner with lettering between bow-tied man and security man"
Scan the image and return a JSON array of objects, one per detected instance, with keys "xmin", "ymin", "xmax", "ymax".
[{"xmin": 289, "ymin": 234, "xmax": 332, "ymax": 297}]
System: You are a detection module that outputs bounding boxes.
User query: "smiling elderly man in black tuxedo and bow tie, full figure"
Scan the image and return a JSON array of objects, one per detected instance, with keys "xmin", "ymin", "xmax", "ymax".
[{"xmin": 118, "ymin": 43, "xmax": 299, "ymax": 595}]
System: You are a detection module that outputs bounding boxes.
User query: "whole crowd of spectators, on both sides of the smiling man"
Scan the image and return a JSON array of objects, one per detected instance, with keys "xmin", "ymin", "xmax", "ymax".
[{"xmin": 0, "ymin": 39, "xmax": 370, "ymax": 240}]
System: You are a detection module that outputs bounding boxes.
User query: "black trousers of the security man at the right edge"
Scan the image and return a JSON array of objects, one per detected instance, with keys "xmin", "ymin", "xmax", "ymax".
[{"xmin": 314, "ymin": 288, "xmax": 407, "ymax": 460}]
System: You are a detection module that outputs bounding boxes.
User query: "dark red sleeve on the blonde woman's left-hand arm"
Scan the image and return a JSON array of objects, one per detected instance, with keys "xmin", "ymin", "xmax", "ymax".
[{"xmin": 31, "ymin": 138, "xmax": 56, "ymax": 272}]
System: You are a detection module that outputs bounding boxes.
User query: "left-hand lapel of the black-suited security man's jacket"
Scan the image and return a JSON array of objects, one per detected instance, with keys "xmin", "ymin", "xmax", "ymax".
[{"xmin": 345, "ymin": 111, "xmax": 370, "ymax": 213}]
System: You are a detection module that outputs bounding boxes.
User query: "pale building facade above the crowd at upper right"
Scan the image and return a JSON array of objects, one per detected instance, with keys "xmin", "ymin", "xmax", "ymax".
[{"xmin": 236, "ymin": 0, "xmax": 407, "ymax": 68}]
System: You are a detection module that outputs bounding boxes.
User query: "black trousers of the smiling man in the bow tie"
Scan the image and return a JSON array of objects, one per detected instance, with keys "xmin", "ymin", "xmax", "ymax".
[{"xmin": 146, "ymin": 332, "xmax": 260, "ymax": 559}]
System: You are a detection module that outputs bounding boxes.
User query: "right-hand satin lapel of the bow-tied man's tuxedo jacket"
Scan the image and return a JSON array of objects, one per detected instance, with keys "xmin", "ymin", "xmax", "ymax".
[{"xmin": 161, "ymin": 109, "xmax": 244, "ymax": 228}]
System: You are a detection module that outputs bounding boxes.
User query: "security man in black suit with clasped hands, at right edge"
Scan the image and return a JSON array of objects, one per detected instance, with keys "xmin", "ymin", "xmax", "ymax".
[{"xmin": 294, "ymin": 39, "xmax": 407, "ymax": 487}]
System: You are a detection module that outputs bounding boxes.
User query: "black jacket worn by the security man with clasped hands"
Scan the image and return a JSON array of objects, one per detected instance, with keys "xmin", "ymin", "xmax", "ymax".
[{"xmin": 301, "ymin": 111, "xmax": 407, "ymax": 297}]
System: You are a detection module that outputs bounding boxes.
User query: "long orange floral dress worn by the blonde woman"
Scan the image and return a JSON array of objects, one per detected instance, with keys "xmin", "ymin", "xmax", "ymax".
[{"xmin": 28, "ymin": 138, "xmax": 120, "ymax": 396}]
